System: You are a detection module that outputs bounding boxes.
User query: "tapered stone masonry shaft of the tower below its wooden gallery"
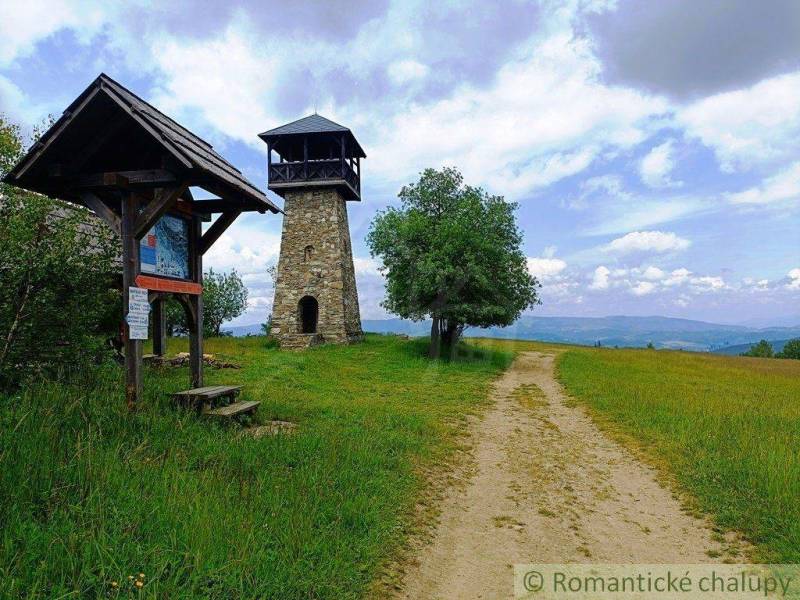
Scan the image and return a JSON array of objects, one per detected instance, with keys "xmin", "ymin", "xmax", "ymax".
[{"xmin": 272, "ymin": 187, "xmax": 363, "ymax": 348}]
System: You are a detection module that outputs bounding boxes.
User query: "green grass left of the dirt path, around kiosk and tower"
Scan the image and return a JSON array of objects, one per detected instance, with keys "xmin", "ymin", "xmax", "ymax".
[{"xmin": 0, "ymin": 336, "xmax": 511, "ymax": 600}]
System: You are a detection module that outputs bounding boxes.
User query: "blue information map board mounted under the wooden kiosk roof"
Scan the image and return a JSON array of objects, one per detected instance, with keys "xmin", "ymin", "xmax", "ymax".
[{"xmin": 139, "ymin": 215, "xmax": 191, "ymax": 279}]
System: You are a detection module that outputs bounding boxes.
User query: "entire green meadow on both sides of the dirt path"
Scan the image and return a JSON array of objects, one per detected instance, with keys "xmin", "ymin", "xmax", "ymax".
[{"xmin": 0, "ymin": 335, "xmax": 800, "ymax": 599}]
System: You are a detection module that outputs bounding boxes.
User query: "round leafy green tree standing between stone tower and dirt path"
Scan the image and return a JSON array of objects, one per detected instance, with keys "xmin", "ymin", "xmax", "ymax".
[{"xmin": 367, "ymin": 168, "xmax": 539, "ymax": 357}]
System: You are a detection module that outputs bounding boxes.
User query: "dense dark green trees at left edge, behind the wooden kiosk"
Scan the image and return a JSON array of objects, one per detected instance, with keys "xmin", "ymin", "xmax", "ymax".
[{"xmin": 0, "ymin": 115, "xmax": 120, "ymax": 388}]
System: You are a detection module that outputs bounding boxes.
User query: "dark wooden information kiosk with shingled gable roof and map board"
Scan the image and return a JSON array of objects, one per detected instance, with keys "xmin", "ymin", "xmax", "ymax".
[{"xmin": 5, "ymin": 74, "xmax": 281, "ymax": 409}]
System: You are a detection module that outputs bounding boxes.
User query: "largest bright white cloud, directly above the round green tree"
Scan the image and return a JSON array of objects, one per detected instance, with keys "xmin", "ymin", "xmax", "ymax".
[{"xmin": 358, "ymin": 31, "xmax": 666, "ymax": 197}]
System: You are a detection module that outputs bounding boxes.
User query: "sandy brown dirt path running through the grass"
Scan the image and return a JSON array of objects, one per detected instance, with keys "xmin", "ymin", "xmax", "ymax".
[{"xmin": 399, "ymin": 352, "xmax": 732, "ymax": 600}]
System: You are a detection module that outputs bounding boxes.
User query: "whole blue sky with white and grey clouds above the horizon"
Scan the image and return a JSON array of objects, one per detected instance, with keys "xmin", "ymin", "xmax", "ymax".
[{"xmin": 0, "ymin": 0, "xmax": 800, "ymax": 324}]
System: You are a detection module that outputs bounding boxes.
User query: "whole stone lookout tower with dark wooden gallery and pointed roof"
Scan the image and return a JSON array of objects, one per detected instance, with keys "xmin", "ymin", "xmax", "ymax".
[{"xmin": 259, "ymin": 114, "xmax": 366, "ymax": 348}]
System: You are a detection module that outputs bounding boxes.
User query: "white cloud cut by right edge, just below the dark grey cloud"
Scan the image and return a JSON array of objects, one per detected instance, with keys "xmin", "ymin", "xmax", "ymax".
[{"xmin": 676, "ymin": 72, "xmax": 800, "ymax": 172}]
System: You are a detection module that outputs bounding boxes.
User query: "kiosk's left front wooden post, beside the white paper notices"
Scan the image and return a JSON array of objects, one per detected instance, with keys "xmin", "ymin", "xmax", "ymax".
[{"xmin": 120, "ymin": 193, "xmax": 142, "ymax": 410}]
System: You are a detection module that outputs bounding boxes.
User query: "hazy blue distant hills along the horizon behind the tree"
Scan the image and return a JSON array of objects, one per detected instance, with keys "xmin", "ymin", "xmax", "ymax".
[{"xmin": 362, "ymin": 316, "xmax": 800, "ymax": 352}]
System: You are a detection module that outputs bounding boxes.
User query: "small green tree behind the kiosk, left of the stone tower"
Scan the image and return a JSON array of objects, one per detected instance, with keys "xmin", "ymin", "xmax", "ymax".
[{"xmin": 167, "ymin": 269, "xmax": 247, "ymax": 337}]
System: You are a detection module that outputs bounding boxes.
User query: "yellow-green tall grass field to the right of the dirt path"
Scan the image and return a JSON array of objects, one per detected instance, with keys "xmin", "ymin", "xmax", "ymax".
[{"xmin": 558, "ymin": 348, "xmax": 800, "ymax": 563}]
